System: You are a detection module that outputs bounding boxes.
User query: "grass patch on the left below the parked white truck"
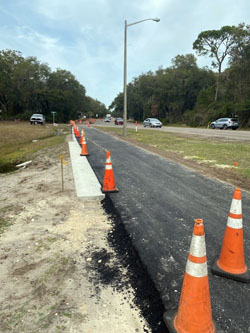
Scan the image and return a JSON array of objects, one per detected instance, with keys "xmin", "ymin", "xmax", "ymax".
[{"xmin": 0, "ymin": 122, "xmax": 68, "ymax": 172}]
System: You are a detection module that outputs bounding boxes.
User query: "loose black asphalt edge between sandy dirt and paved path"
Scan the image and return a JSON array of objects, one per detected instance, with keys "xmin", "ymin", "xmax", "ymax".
[{"xmin": 102, "ymin": 195, "xmax": 169, "ymax": 333}]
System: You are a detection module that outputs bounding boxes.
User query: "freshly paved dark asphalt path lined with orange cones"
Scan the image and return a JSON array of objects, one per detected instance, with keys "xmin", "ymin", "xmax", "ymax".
[{"xmin": 81, "ymin": 128, "xmax": 250, "ymax": 333}]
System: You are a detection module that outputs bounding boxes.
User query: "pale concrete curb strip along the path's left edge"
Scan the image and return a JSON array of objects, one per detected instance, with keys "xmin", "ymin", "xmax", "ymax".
[{"xmin": 69, "ymin": 135, "xmax": 105, "ymax": 200}]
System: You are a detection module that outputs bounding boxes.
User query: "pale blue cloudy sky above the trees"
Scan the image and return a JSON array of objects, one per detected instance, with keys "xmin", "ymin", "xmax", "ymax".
[{"xmin": 0, "ymin": 0, "xmax": 250, "ymax": 107}]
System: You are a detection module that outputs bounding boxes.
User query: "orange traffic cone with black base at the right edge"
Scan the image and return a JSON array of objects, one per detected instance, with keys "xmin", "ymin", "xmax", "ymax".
[{"xmin": 212, "ymin": 188, "xmax": 250, "ymax": 282}]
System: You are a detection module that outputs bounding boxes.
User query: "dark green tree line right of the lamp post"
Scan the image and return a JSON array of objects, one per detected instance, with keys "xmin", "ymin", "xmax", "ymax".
[{"xmin": 109, "ymin": 23, "xmax": 250, "ymax": 127}]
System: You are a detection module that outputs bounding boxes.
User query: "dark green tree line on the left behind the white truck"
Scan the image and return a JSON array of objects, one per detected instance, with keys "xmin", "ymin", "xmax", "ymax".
[{"xmin": 0, "ymin": 50, "xmax": 107, "ymax": 122}]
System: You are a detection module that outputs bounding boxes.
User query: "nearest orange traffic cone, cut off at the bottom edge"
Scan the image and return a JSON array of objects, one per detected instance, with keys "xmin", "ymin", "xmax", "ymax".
[{"xmin": 163, "ymin": 219, "xmax": 223, "ymax": 333}]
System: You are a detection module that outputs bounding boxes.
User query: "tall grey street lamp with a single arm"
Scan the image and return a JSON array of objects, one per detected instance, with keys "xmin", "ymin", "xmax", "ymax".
[{"xmin": 123, "ymin": 18, "xmax": 160, "ymax": 136}]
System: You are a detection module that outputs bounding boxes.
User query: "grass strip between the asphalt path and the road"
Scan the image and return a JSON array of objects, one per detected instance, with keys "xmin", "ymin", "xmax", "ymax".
[{"xmin": 96, "ymin": 127, "xmax": 250, "ymax": 179}]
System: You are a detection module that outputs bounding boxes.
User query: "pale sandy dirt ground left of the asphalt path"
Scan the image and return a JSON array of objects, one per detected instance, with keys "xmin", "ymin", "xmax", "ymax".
[{"xmin": 0, "ymin": 136, "xmax": 151, "ymax": 333}]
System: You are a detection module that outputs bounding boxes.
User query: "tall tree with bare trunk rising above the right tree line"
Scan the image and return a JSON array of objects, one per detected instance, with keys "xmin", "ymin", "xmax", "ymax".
[{"xmin": 193, "ymin": 24, "xmax": 247, "ymax": 102}]
